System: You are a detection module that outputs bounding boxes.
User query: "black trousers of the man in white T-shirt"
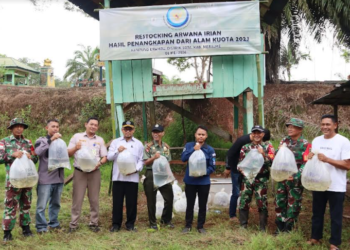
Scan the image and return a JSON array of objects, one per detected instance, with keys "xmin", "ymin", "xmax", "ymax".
[{"xmin": 311, "ymin": 191, "xmax": 345, "ymax": 246}]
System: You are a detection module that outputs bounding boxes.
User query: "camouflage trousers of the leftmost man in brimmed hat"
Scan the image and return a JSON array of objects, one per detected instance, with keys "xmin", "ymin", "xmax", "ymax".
[{"xmin": 2, "ymin": 187, "xmax": 32, "ymax": 230}]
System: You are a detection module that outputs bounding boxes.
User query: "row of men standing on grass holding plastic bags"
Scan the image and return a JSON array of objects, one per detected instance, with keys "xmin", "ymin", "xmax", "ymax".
[{"xmin": 0, "ymin": 115, "xmax": 350, "ymax": 250}]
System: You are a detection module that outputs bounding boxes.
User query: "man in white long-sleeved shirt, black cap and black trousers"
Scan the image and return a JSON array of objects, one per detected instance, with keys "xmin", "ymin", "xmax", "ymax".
[{"xmin": 107, "ymin": 121, "xmax": 144, "ymax": 232}]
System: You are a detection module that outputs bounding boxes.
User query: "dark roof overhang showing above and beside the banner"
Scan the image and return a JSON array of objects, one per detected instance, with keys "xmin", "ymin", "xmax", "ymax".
[{"xmin": 68, "ymin": 0, "xmax": 288, "ymax": 25}]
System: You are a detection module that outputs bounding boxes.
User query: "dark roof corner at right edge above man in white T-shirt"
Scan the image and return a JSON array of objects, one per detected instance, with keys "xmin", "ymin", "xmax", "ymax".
[{"xmin": 311, "ymin": 81, "xmax": 350, "ymax": 105}]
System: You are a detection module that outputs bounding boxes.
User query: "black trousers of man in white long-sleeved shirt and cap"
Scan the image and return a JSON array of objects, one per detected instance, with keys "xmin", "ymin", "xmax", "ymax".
[{"xmin": 112, "ymin": 181, "xmax": 139, "ymax": 228}]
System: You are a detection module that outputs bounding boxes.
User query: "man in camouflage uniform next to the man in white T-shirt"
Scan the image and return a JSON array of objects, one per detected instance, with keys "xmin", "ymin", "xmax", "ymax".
[{"xmin": 275, "ymin": 118, "xmax": 310, "ymax": 234}]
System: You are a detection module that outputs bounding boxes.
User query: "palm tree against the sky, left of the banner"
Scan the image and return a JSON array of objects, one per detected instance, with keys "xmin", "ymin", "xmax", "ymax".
[{"xmin": 63, "ymin": 44, "xmax": 100, "ymax": 81}]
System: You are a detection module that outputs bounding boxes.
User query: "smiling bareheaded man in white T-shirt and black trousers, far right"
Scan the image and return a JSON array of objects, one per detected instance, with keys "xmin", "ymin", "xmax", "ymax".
[{"xmin": 308, "ymin": 115, "xmax": 350, "ymax": 250}]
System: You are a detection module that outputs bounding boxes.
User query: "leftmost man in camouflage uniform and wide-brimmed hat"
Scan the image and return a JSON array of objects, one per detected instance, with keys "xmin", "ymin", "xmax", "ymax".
[{"xmin": 0, "ymin": 118, "xmax": 38, "ymax": 241}]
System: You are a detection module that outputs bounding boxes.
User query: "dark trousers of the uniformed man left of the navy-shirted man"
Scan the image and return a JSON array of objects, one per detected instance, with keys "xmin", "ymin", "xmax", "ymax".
[{"xmin": 143, "ymin": 169, "xmax": 174, "ymax": 226}]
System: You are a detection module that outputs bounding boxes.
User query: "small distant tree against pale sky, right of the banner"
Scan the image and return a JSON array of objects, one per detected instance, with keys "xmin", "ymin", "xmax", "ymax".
[{"xmin": 280, "ymin": 42, "xmax": 311, "ymax": 81}]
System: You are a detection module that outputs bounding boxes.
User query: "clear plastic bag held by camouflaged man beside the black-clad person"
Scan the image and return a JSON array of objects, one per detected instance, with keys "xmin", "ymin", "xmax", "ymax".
[{"xmin": 237, "ymin": 149, "xmax": 264, "ymax": 183}]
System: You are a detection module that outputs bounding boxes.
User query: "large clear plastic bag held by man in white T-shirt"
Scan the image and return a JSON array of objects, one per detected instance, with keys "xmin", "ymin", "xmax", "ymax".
[{"xmin": 301, "ymin": 152, "xmax": 332, "ymax": 191}]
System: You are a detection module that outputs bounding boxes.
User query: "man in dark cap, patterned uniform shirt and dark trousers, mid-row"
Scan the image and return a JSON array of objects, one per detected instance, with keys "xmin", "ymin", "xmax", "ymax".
[{"xmin": 143, "ymin": 124, "xmax": 174, "ymax": 230}]
